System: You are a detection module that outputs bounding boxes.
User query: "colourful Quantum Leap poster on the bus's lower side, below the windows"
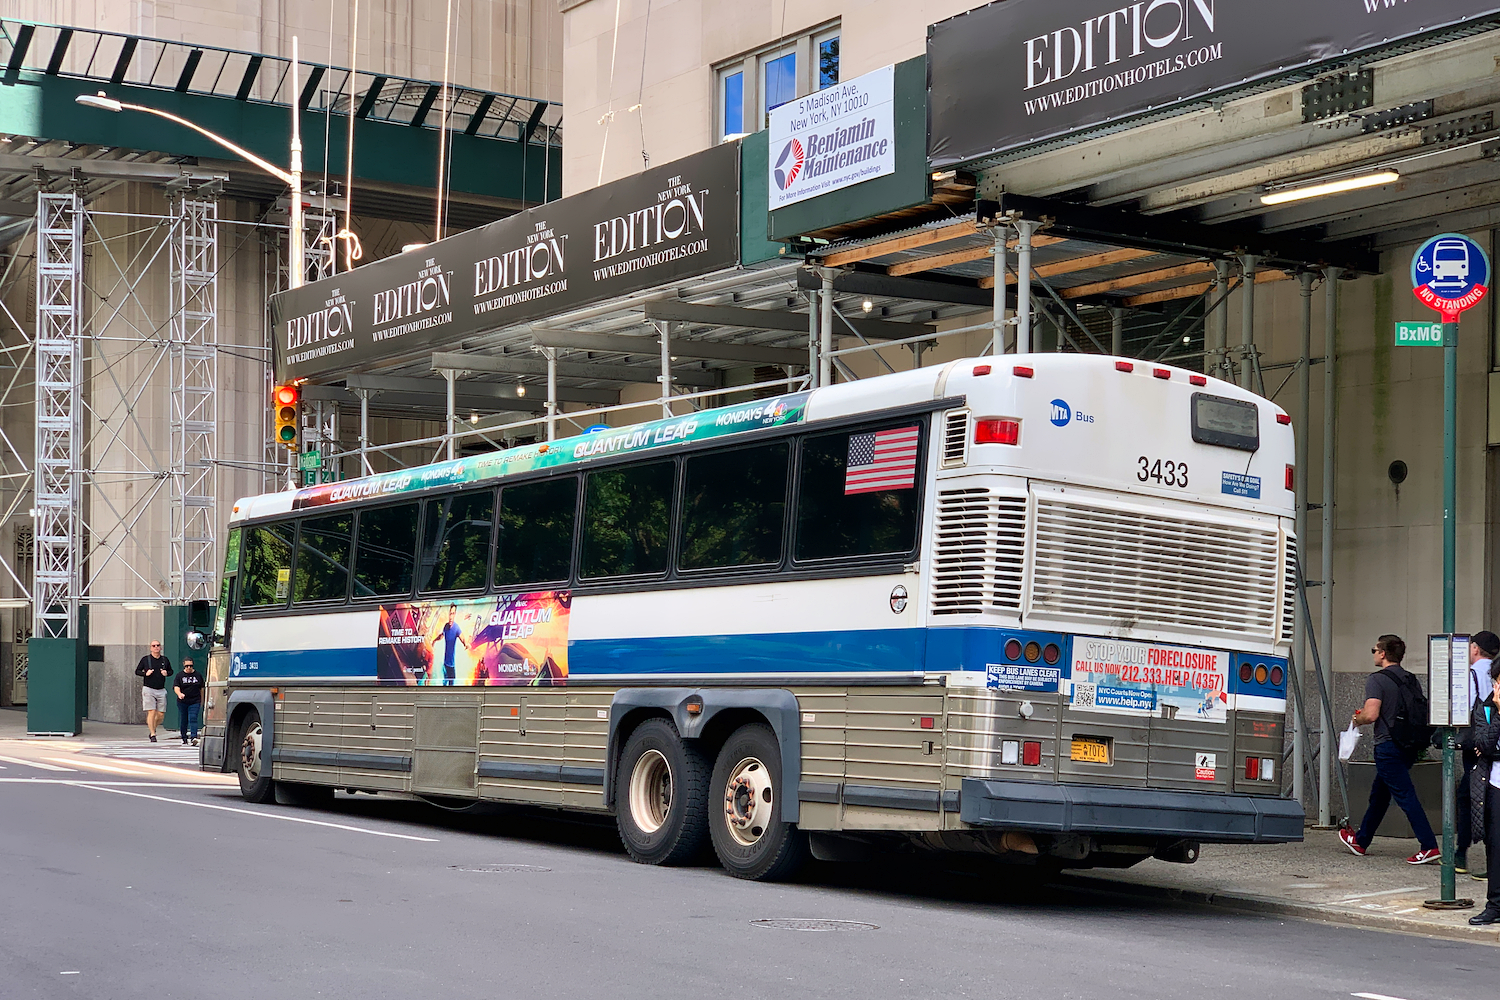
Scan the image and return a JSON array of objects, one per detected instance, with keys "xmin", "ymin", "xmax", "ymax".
[{"xmin": 375, "ymin": 591, "xmax": 573, "ymax": 687}]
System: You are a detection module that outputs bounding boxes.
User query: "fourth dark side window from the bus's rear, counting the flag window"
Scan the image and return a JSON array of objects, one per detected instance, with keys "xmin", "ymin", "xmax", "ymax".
[{"xmin": 495, "ymin": 478, "xmax": 578, "ymax": 589}]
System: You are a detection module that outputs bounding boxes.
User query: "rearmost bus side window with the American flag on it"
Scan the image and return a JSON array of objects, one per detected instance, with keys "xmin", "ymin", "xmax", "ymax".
[{"xmin": 797, "ymin": 424, "xmax": 921, "ymax": 561}]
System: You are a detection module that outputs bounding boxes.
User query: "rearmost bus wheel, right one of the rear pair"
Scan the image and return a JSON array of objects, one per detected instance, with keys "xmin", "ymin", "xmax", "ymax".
[{"xmin": 708, "ymin": 723, "xmax": 807, "ymax": 882}]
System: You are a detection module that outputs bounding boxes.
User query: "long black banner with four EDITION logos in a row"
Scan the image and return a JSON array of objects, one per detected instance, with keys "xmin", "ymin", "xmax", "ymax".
[{"xmin": 272, "ymin": 144, "xmax": 740, "ymax": 381}]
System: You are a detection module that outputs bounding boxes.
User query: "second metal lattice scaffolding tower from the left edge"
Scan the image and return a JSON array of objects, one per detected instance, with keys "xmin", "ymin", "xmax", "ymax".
[{"xmin": 167, "ymin": 196, "xmax": 219, "ymax": 601}]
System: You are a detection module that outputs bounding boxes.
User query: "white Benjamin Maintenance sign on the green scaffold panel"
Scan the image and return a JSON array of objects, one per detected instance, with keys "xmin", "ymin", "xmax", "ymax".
[{"xmin": 767, "ymin": 66, "xmax": 896, "ymax": 210}]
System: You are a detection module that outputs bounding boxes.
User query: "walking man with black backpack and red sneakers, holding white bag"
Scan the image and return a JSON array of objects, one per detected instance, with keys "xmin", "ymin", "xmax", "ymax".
[{"xmin": 1338, "ymin": 636, "xmax": 1443, "ymax": 865}]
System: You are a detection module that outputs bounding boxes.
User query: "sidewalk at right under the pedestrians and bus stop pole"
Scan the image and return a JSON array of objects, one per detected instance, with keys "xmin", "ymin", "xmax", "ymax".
[{"xmin": 1067, "ymin": 831, "xmax": 1500, "ymax": 945}]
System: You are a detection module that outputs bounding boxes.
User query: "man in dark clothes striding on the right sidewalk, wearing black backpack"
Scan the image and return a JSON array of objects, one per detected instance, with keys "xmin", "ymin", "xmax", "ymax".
[{"xmin": 1338, "ymin": 636, "xmax": 1443, "ymax": 865}]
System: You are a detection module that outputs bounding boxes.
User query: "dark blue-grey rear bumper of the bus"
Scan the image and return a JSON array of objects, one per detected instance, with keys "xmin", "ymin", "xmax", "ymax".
[{"xmin": 959, "ymin": 778, "xmax": 1304, "ymax": 844}]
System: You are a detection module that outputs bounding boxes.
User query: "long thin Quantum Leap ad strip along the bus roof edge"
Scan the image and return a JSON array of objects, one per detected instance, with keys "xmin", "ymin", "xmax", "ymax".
[{"xmin": 291, "ymin": 393, "xmax": 810, "ymax": 510}]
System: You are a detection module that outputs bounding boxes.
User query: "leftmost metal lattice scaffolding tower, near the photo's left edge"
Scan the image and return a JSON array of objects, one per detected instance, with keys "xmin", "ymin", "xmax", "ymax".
[{"xmin": 32, "ymin": 192, "xmax": 84, "ymax": 637}]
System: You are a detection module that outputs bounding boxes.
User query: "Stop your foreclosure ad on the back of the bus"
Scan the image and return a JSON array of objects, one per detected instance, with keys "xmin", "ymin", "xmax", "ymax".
[{"xmin": 1068, "ymin": 636, "xmax": 1229, "ymax": 723}]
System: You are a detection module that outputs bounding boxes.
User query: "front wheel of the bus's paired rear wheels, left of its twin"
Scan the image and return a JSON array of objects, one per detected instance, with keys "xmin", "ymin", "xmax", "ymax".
[{"xmin": 615, "ymin": 718, "xmax": 710, "ymax": 865}]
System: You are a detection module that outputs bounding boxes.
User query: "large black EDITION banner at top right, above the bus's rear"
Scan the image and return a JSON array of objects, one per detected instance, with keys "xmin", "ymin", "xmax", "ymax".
[{"xmin": 927, "ymin": 0, "xmax": 1500, "ymax": 168}]
